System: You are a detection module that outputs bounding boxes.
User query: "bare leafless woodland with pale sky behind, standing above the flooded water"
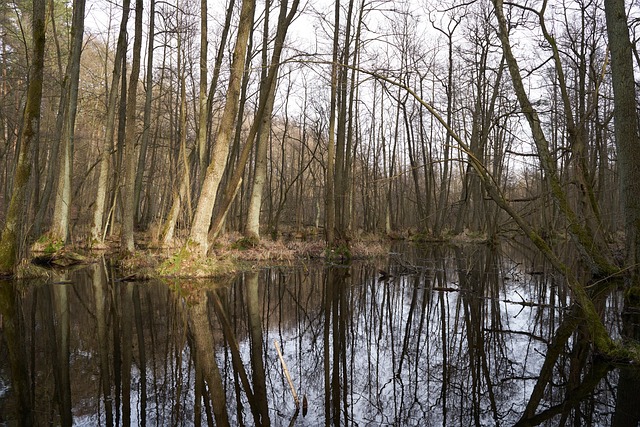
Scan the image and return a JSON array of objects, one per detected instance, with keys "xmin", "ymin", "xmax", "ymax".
[{"xmin": 0, "ymin": 0, "xmax": 640, "ymax": 360}]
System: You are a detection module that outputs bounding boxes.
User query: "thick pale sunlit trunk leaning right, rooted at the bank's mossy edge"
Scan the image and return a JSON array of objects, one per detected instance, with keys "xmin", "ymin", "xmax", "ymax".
[{"xmin": 189, "ymin": 0, "xmax": 255, "ymax": 255}]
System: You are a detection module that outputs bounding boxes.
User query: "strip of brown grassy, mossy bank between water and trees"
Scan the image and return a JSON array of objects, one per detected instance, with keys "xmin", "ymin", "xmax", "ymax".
[{"xmin": 16, "ymin": 229, "xmax": 486, "ymax": 280}]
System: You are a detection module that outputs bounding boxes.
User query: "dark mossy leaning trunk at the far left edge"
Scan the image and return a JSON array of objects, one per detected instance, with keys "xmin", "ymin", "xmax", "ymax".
[{"xmin": 0, "ymin": 0, "xmax": 45, "ymax": 274}]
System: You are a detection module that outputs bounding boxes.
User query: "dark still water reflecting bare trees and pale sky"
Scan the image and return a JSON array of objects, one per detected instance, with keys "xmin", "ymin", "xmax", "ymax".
[{"xmin": 0, "ymin": 247, "xmax": 640, "ymax": 426}]
